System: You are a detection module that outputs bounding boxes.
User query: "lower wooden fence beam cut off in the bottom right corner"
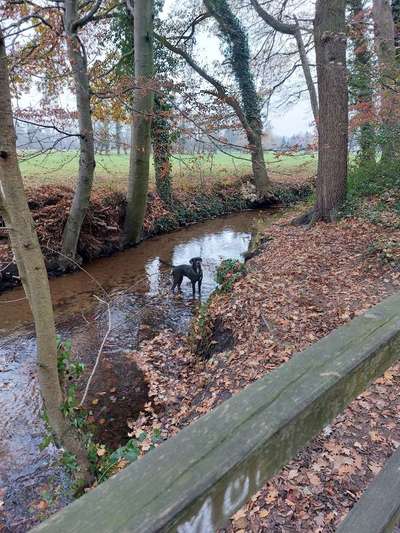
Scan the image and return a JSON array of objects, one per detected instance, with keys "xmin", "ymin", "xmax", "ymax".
[{"xmin": 336, "ymin": 448, "xmax": 400, "ymax": 533}]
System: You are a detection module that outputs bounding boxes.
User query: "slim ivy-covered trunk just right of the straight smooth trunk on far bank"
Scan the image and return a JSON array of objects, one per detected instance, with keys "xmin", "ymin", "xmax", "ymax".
[{"xmin": 151, "ymin": 95, "xmax": 172, "ymax": 205}]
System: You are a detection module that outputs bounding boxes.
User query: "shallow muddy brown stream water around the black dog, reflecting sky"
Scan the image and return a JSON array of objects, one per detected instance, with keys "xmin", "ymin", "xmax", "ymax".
[{"xmin": 0, "ymin": 211, "xmax": 279, "ymax": 531}]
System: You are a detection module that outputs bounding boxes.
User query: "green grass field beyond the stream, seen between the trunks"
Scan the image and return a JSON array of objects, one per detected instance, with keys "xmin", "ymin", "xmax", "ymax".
[{"xmin": 21, "ymin": 151, "xmax": 316, "ymax": 190}]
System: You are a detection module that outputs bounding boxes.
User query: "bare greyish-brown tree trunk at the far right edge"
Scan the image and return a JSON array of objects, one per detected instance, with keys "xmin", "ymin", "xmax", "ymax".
[{"xmin": 373, "ymin": 0, "xmax": 400, "ymax": 164}]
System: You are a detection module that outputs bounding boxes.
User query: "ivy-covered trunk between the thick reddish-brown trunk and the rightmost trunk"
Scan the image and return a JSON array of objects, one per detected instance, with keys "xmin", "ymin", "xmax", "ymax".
[{"xmin": 349, "ymin": 0, "xmax": 376, "ymax": 165}]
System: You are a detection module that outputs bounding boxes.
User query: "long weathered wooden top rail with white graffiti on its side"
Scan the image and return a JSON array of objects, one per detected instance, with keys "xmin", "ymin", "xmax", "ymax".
[{"xmin": 35, "ymin": 294, "xmax": 400, "ymax": 533}]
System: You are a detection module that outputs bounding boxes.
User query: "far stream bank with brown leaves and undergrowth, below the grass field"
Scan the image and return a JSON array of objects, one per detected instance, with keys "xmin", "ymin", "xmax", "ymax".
[{"xmin": 0, "ymin": 178, "xmax": 312, "ymax": 291}]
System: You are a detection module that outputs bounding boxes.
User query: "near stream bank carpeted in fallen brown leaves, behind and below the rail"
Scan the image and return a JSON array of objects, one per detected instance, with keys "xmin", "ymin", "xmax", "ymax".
[{"xmin": 123, "ymin": 202, "xmax": 400, "ymax": 532}]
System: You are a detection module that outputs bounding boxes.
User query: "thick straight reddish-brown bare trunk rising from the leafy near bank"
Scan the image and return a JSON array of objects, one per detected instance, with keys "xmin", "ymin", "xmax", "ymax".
[{"xmin": 314, "ymin": 0, "xmax": 348, "ymax": 221}]
